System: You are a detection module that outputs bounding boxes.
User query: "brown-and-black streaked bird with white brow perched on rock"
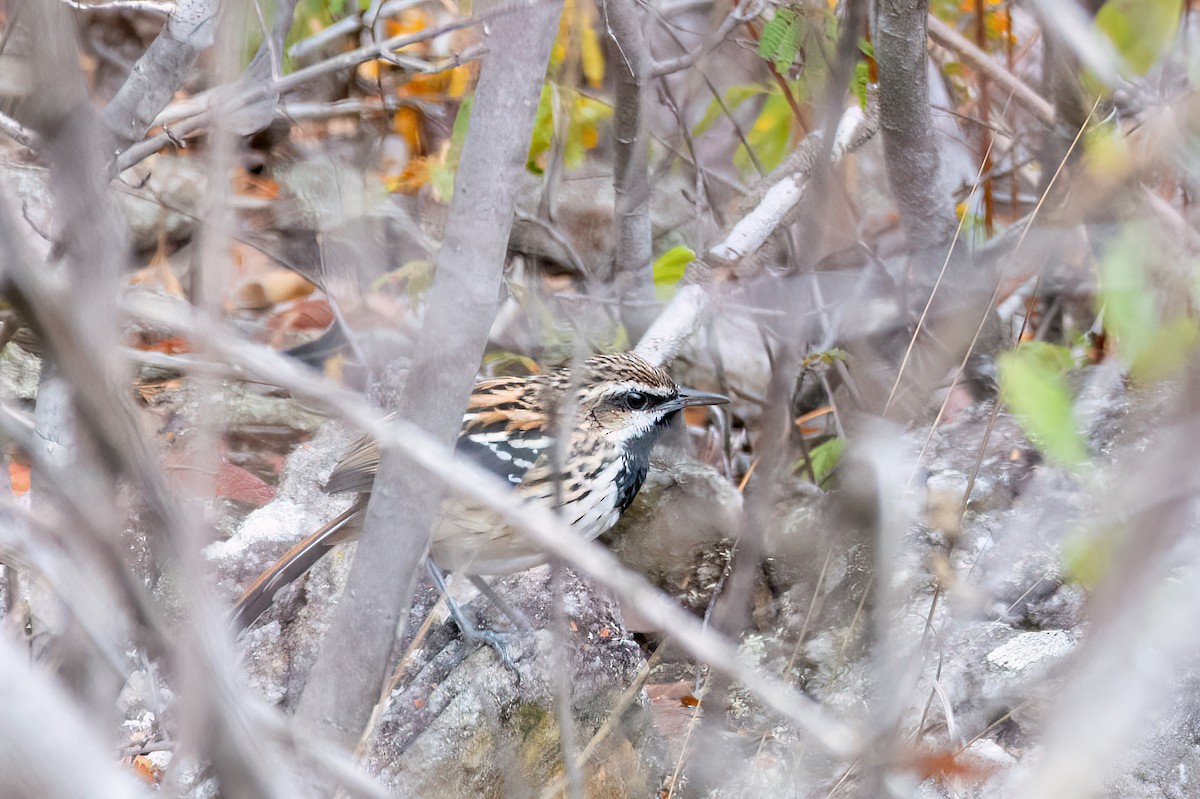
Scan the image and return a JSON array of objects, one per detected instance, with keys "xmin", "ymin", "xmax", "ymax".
[{"xmin": 232, "ymin": 353, "xmax": 728, "ymax": 638}]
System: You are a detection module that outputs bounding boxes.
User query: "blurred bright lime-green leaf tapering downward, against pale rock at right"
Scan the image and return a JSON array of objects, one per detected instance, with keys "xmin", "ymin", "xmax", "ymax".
[{"xmin": 998, "ymin": 342, "xmax": 1087, "ymax": 467}]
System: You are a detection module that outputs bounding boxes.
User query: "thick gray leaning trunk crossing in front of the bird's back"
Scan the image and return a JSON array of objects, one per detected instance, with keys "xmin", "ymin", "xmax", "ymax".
[{"xmin": 298, "ymin": 4, "xmax": 560, "ymax": 745}]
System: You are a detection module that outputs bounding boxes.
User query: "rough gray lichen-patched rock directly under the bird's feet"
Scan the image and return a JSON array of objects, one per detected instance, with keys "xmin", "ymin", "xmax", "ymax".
[{"xmin": 366, "ymin": 566, "xmax": 659, "ymax": 797}]
